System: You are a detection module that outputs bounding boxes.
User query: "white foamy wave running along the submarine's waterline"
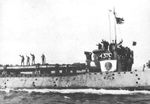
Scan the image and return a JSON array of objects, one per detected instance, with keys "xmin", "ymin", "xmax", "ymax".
[{"xmin": 0, "ymin": 89, "xmax": 150, "ymax": 95}]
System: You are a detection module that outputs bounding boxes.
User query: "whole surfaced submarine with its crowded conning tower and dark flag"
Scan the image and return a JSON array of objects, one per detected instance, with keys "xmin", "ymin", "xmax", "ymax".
[{"xmin": 0, "ymin": 10, "xmax": 150, "ymax": 90}]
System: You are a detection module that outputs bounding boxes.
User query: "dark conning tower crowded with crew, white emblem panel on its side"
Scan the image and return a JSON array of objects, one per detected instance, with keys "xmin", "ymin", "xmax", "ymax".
[{"xmin": 85, "ymin": 40, "xmax": 134, "ymax": 71}]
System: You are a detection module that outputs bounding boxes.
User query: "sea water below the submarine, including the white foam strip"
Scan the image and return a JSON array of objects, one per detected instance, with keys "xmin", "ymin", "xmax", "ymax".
[{"xmin": 0, "ymin": 89, "xmax": 150, "ymax": 104}]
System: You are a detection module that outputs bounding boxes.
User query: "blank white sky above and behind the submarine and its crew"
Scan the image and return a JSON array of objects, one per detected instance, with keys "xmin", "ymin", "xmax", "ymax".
[{"xmin": 0, "ymin": 0, "xmax": 150, "ymax": 66}]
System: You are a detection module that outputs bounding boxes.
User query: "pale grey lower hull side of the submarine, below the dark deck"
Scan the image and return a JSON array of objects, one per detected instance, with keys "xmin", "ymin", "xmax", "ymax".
[{"xmin": 0, "ymin": 70, "xmax": 150, "ymax": 90}]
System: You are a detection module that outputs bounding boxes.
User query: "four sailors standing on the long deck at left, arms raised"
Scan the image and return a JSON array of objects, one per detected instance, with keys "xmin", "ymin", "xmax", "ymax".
[{"xmin": 19, "ymin": 53, "xmax": 46, "ymax": 66}]
